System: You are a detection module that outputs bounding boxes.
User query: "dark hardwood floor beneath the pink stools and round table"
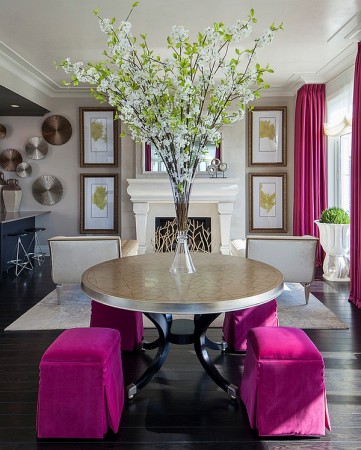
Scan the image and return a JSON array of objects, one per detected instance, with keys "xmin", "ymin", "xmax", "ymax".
[{"xmin": 0, "ymin": 261, "xmax": 361, "ymax": 450}]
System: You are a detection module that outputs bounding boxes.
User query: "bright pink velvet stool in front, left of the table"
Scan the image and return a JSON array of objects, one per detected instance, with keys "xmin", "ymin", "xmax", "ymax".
[{"xmin": 36, "ymin": 328, "xmax": 124, "ymax": 438}]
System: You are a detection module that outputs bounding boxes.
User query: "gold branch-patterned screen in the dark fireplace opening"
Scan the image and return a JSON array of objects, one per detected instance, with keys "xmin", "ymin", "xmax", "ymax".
[{"xmin": 154, "ymin": 217, "xmax": 212, "ymax": 253}]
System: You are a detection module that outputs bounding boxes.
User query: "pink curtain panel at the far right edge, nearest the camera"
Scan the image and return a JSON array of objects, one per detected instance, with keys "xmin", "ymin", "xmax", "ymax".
[{"xmin": 349, "ymin": 42, "xmax": 361, "ymax": 308}]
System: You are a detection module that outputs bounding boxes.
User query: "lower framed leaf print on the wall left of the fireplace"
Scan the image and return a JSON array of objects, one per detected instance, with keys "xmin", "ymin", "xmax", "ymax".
[{"xmin": 80, "ymin": 174, "xmax": 118, "ymax": 234}]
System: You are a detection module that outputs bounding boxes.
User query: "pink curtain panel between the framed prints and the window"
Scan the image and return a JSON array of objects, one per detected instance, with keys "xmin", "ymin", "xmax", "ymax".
[{"xmin": 293, "ymin": 84, "xmax": 327, "ymax": 266}]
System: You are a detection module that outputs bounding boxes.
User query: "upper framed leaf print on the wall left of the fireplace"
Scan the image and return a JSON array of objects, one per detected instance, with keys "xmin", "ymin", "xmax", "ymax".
[{"xmin": 79, "ymin": 108, "xmax": 118, "ymax": 167}]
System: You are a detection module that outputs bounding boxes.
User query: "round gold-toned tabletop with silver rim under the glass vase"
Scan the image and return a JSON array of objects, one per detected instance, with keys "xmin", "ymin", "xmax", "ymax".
[{"xmin": 82, "ymin": 253, "xmax": 283, "ymax": 313}]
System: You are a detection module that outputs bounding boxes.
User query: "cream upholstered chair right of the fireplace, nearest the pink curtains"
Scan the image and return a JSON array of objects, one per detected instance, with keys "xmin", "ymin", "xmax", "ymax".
[{"xmin": 246, "ymin": 236, "xmax": 318, "ymax": 303}]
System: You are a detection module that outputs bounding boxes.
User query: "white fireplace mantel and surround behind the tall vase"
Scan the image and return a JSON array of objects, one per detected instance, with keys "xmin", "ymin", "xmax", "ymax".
[{"xmin": 127, "ymin": 177, "xmax": 239, "ymax": 255}]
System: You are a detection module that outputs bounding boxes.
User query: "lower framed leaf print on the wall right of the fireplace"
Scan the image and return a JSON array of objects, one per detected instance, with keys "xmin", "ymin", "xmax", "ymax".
[{"xmin": 249, "ymin": 173, "xmax": 287, "ymax": 233}]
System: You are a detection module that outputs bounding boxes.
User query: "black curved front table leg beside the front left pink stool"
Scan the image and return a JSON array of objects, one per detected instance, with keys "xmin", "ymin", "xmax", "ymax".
[{"xmin": 126, "ymin": 313, "xmax": 171, "ymax": 398}]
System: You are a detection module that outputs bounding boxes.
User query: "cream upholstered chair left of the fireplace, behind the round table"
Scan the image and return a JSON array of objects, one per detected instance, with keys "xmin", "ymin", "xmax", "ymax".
[{"xmin": 48, "ymin": 236, "xmax": 138, "ymax": 303}]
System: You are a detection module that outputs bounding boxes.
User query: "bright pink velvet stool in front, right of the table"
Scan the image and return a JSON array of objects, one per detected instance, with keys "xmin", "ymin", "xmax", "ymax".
[{"xmin": 240, "ymin": 327, "xmax": 331, "ymax": 436}]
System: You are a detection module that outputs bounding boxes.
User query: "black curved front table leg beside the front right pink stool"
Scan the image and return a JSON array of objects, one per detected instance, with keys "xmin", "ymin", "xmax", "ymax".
[{"xmin": 194, "ymin": 313, "xmax": 238, "ymax": 399}]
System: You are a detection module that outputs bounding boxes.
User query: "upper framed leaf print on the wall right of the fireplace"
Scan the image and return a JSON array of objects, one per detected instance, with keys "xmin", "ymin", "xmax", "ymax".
[{"xmin": 248, "ymin": 106, "xmax": 287, "ymax": 166}]
